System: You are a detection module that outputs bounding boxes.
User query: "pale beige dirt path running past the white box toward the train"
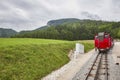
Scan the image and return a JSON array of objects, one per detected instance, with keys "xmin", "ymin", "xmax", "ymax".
[{"xmin": 57, "ymin": 50, "xmax": 94, "ymax": 80}]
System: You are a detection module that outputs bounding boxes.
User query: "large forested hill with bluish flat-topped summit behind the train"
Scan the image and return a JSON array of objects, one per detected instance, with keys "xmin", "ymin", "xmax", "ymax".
[{"xmin": 13, "ymin": 19, "xmax": 120, "ymax": 40}]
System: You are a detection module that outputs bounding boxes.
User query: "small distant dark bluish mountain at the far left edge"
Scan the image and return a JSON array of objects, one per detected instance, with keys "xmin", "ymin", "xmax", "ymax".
[{"xmin": 0, "ymin": 28, "xmax": 17, "ymax": 37}]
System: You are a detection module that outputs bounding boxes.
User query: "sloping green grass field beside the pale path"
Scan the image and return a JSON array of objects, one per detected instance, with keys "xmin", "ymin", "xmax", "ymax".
[{"xmin": 0, "ymin": 38, "xmax": 93, "ymax": 80}]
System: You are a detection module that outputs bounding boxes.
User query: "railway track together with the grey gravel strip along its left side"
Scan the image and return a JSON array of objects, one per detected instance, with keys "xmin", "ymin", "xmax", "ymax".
[{"xmin": 72, "ymin": 53, "xmax": 109, "ymax": 80}]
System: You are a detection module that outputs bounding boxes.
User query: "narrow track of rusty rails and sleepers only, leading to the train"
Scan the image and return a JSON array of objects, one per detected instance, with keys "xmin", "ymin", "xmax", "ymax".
[{"xmin": 85, "ymin": 53, "xmax": 108, "ymax": 80}]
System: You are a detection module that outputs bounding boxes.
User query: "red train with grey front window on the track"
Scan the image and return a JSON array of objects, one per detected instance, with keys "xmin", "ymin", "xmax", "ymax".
[{"xmin": 94, "ymin": 32, "xmax": 114, "ymax": 52}]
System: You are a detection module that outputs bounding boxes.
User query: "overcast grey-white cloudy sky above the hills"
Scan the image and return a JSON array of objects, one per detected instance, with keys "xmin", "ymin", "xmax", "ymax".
[{"xmin": 0, "ymin": 0, "xmax": 120, "ymax": 31}]
